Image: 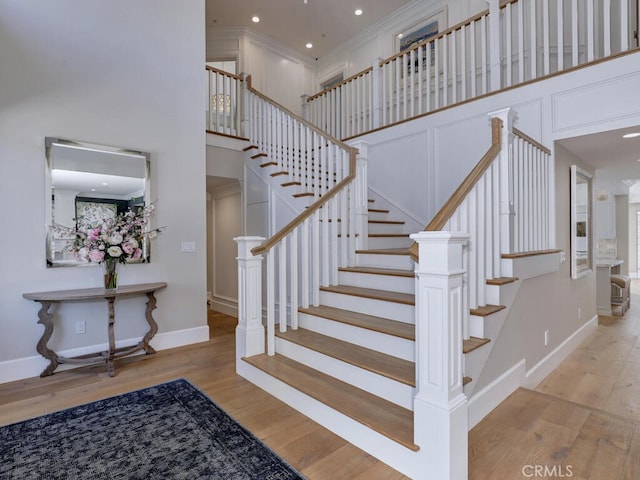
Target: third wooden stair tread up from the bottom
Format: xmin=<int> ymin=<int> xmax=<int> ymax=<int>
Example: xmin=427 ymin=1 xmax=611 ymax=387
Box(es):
xmin=298 ymin=305 xmax=416 ymax=341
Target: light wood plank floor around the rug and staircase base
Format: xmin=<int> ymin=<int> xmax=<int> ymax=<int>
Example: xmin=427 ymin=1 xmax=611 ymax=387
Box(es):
xmin=0 ymin=281 xmax=640 ymax=480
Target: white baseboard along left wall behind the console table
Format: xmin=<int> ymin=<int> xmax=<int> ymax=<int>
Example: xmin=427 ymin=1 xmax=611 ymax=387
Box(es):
xmin=0 ymin=326 xmax=209 ymax=383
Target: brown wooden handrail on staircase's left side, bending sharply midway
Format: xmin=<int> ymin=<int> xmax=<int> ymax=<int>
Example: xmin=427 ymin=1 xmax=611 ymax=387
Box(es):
xmin=247 ymin=76 xmax=358 ymax=255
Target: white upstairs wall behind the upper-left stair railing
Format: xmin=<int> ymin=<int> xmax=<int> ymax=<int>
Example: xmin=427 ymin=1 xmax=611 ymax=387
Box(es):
xmin=207 ymin=28 xmax=315 ymax=115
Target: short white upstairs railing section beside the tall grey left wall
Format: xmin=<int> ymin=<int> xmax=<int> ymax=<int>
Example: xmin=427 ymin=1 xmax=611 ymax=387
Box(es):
xmin=205 ymin=65 xmax=242 ymax=137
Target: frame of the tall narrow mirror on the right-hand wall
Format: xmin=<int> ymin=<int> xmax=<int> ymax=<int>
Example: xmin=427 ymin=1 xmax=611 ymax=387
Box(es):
xmin=569 ymin=165 xmax=593 ymax=279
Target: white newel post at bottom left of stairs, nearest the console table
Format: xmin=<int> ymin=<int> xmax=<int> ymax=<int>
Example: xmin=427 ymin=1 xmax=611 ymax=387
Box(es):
xmin=234 ymin=237 xmax=265 ymax=363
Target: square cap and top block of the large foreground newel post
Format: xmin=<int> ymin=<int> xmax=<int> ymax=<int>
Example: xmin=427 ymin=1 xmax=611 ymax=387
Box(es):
xmin=410 ymin=232 xmax=469 ymax=274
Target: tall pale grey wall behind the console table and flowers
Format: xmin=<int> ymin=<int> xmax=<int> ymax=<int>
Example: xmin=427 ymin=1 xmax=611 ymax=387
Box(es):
xmin=0 ymin=0 xmax=208 ymax=382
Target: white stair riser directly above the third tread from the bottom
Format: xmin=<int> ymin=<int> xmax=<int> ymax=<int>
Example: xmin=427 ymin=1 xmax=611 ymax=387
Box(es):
xmin=320 ymin=291 xmax=415 ymax=324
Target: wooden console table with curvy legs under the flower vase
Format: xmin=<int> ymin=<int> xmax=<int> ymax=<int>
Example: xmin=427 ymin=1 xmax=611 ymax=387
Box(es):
xmin=22 ymin=282 xmax=167 ymax=377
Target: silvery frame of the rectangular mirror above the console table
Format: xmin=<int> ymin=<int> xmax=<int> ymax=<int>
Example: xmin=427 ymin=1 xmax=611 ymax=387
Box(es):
xmin=45 ymin=137 xmax=152 ymax=268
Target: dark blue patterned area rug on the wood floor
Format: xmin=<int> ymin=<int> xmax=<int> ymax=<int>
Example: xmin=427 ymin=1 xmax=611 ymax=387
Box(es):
xmin=0 ymin=380 xmax=304 ymax=480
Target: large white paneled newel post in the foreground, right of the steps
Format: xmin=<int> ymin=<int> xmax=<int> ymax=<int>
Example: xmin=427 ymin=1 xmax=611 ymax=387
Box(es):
xmin=411 ymin=232 xmax=469 ymax=480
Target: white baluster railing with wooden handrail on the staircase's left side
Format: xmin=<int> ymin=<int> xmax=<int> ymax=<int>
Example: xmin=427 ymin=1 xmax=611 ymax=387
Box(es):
xmin=239 ymin=77 xmax=359 ymax=355
